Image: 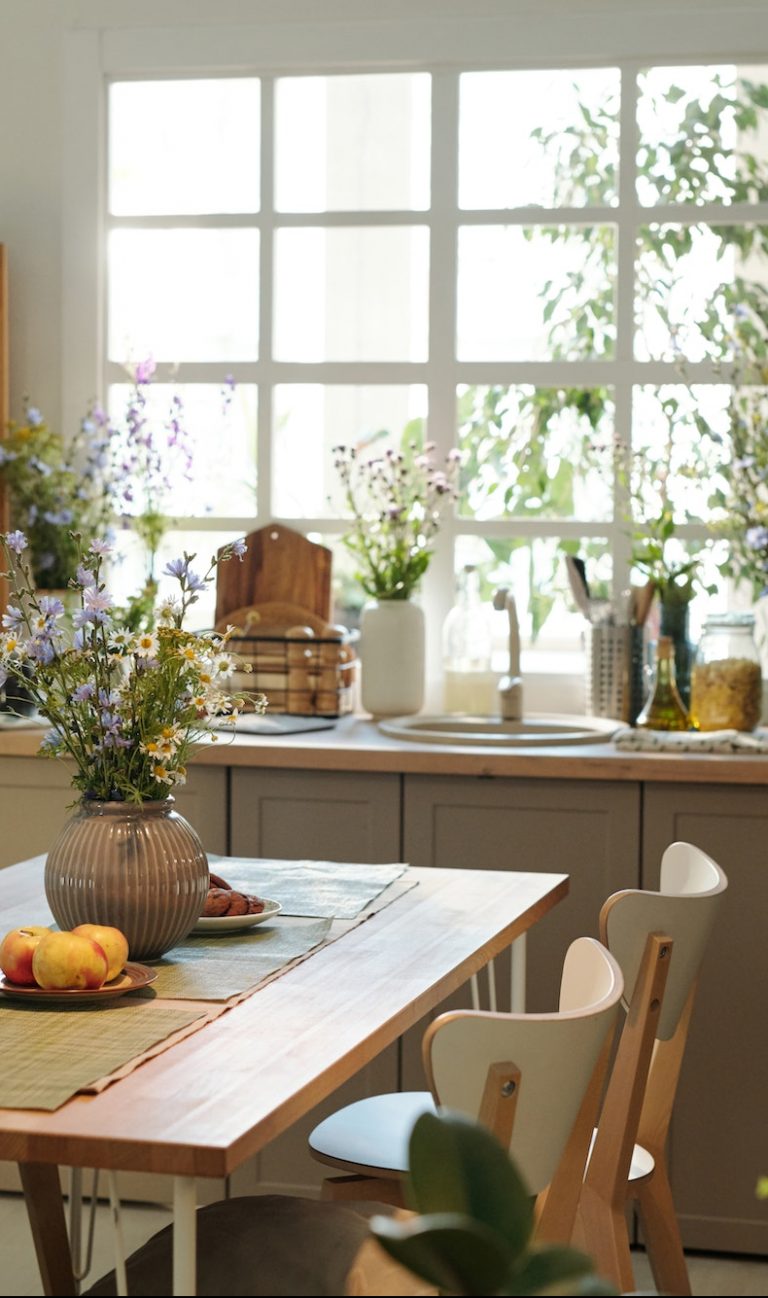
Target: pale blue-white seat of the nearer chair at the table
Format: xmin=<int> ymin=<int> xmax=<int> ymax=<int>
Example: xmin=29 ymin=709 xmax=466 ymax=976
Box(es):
xmin=309 ymin=1090 xmax=435 ymax=1177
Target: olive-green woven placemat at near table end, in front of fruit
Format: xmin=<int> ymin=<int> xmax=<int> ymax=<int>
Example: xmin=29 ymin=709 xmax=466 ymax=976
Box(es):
xmin=0 ymin=999 xmax=201 ymax=1110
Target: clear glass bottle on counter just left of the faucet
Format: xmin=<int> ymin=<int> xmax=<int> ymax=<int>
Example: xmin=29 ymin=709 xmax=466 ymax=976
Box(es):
xmin=442 ymin=563 xmax=498 ymax=716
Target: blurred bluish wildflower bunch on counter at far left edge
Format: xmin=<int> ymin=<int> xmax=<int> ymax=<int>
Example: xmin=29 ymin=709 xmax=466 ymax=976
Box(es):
xmin=0 ymin=404 xmax=113 ymax=589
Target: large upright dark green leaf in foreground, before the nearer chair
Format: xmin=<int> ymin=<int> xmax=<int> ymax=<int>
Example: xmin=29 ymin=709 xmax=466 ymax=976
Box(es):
xmin=409 ymin=1112 xmax=533 ymax=1263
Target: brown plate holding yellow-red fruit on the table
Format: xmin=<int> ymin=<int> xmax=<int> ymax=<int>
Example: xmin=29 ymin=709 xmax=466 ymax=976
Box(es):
xmin=0 ymin=924 xmax=157 ymax=1001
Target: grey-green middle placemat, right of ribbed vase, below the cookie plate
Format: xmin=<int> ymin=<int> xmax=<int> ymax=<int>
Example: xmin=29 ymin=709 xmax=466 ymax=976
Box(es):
xmin=147 ymin=919 xmax=331 ymax=1001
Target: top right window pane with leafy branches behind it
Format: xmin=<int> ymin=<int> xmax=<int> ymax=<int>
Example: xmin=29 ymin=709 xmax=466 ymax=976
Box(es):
xmin=637 ymin=66 xmax=768 ymax=206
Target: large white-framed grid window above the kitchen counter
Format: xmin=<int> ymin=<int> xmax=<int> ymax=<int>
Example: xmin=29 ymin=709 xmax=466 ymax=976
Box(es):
xmin=97 ymin=49 xmax=768 ymax=695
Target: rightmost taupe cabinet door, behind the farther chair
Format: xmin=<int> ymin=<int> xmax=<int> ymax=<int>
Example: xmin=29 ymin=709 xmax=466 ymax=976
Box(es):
xmin=642 ymin=778 xmax=768 ymax=1254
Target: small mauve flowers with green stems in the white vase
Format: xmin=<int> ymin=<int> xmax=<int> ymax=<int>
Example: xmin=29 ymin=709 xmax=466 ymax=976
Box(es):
xmin=333 ymin=443 xmax=461 ymax=600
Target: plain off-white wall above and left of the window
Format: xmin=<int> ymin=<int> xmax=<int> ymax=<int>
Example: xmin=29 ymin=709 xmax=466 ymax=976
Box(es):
xmin=0 ymin=0 xmax=768 ymax=423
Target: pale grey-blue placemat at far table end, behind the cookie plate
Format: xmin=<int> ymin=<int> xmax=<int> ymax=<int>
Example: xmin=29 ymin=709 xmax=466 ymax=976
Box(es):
xmin=209 ymin=857 xmax=407 ymax=919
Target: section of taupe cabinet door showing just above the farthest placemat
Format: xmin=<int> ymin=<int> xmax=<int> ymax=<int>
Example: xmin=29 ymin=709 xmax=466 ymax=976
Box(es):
xmin=230 ymin=770 xmax=401 ymax=864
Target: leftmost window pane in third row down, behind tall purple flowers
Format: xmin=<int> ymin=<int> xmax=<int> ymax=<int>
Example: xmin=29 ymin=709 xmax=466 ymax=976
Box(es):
xmin=109 ymin=382 xmax=256 ymax=518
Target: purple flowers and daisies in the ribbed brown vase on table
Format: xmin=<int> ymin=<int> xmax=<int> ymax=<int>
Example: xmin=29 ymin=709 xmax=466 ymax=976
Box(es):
xmin=0 ymin=531 xmax=265 ymax=802
